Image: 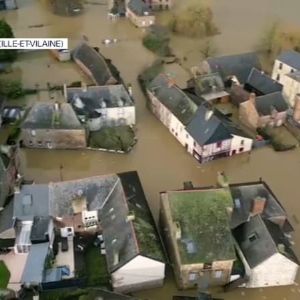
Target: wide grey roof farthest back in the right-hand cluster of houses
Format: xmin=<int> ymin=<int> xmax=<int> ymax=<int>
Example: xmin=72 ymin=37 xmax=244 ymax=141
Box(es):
xmin=207 ymin=52 xmax=260 ymax=83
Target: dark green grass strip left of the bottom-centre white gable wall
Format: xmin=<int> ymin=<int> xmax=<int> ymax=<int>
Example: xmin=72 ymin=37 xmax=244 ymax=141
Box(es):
xmin=84 ymin=246 xmax=110 ymax=286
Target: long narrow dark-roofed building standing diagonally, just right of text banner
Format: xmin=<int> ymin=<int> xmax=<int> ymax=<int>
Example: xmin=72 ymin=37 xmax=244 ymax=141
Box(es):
xmin=72 ymin=42 xmax=119 ymax=85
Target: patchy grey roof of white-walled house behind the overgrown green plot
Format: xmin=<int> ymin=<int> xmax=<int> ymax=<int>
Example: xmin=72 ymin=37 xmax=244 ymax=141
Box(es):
xmin=67 ymin=84 xmax=134 ymax=114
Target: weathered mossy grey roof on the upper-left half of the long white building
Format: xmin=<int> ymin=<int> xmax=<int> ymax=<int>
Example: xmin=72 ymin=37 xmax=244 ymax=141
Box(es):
xmin=147 ymin=74 xmax=197 ymax=125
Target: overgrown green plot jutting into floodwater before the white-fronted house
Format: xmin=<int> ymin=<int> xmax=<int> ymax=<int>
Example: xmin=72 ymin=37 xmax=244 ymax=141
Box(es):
xmin=89 ymin=126 xmax=135 ymax=152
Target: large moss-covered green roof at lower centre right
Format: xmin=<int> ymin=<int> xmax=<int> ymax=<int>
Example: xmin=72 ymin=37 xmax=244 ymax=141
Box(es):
xmin=161 ymin=189 xmax=235 ymax=264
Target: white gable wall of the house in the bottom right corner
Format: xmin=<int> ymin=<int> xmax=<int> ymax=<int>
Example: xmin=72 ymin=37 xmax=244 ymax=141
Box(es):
xmin=246 ymin=253 xmax=298 ymax=288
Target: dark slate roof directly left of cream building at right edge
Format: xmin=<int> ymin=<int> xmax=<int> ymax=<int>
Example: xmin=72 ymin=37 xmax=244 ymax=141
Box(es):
xmin=245 ymin=68 xmax=283 ymax=95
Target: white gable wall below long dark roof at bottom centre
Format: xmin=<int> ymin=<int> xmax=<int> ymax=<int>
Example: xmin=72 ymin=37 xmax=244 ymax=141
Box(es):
xmin=112 ymin=255 xmax=165 ymax=291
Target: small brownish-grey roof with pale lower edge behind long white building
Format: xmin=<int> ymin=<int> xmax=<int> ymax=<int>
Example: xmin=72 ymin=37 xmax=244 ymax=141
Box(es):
xmin=194 ymin=73 xmax=228 ymax=101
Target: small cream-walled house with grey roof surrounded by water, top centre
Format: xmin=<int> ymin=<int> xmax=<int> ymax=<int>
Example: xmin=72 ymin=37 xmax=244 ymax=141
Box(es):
xmin=126 ymin=0 xmax=155 ymax=28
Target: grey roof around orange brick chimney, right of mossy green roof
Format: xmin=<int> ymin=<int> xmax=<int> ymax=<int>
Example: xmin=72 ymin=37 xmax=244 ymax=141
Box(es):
xmin=230 ymin=182 xmax=287 ymax=228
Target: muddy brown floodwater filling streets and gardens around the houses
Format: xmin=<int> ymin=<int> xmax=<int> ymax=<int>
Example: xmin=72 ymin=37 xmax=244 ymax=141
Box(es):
xmin=0 ymin=0 xmax=300 ymax=300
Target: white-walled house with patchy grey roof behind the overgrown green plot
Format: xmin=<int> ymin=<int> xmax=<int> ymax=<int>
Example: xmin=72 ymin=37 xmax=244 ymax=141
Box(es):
xmin=65 ymin=84 xmax=135 ymax=131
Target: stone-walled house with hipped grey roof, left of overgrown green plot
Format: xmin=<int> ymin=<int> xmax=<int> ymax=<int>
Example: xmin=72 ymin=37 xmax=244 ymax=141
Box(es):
xmin=21 ymin=102 xmax=86 ymax=149
